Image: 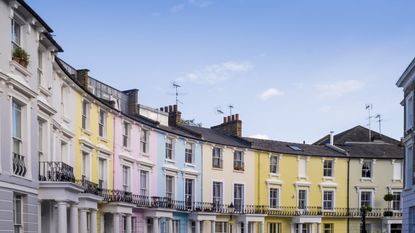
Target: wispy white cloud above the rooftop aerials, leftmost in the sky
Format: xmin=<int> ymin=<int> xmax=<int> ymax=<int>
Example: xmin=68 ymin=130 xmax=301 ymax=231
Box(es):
xmin=178 ymin=61 xmax=253 ymax=85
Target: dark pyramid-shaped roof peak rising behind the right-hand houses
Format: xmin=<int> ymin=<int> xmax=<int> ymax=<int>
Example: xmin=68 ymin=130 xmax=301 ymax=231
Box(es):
xmin=314 ymin=125 xmax=400 ymax=145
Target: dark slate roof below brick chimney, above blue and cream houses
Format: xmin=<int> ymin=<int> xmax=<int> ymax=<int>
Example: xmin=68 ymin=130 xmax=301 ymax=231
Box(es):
xmin=180 ymin=125 xmax=250 ymax=148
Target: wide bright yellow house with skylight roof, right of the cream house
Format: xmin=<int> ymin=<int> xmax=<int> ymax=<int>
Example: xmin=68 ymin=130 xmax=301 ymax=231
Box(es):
xmin=248 ymin=139 xmax=348 ymax=233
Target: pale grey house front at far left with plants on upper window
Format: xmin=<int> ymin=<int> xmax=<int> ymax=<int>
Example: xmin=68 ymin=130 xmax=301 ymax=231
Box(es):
xmin=0 ymin=0 xmax=61 ymax=232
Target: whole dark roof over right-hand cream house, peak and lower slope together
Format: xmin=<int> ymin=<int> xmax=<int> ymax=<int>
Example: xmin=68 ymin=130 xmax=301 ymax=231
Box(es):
xmin=314 ymin=125 xmax=404 ymax=159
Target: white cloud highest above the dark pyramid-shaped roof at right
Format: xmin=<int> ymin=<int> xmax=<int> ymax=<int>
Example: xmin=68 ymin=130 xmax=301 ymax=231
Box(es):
xmin=315 ymin=80 xmax=364 ymax=97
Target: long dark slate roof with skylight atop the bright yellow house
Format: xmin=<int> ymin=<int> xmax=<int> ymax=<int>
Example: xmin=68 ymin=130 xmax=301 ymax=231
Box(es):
xmin=244 ymin=138 xmax=346 ymax=157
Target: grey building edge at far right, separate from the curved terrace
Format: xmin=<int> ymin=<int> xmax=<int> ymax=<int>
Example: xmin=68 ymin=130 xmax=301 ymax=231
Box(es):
xmin=396 ymin=59 xmax=415 ymax=233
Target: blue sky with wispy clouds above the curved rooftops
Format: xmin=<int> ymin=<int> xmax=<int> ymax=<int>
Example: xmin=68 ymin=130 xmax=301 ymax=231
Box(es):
xmin=27 ymin=0 xmax=415 ymax=143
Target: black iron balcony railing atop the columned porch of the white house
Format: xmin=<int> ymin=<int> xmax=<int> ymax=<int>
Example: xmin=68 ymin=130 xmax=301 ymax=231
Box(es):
xmin=39 ymin=161 xmax=75 ymax=183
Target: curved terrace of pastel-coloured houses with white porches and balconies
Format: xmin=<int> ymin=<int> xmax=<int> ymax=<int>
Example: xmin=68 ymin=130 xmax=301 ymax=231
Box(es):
xmin=0 ymin=0 xmax=404 ymax=233
